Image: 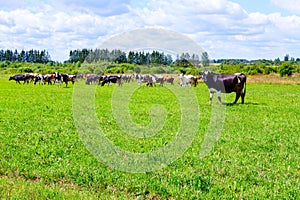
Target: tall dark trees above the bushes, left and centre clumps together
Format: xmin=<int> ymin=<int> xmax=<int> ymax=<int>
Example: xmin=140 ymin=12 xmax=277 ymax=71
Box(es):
xmin=0 ymin=48 xmax=209 ymax=67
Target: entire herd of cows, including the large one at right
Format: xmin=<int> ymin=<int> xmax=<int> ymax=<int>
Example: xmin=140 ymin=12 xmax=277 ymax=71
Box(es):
xmin=9 ymin=71 xmax=246 ymax=104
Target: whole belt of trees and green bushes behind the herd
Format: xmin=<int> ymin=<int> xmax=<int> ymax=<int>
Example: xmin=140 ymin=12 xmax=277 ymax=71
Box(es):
xmin=0 ymin=49 xmax=300 ymax=76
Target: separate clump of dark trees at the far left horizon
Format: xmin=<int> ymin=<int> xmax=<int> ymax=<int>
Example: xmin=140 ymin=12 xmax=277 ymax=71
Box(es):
xmin=0 ymin=49 xmax=51 ymax=63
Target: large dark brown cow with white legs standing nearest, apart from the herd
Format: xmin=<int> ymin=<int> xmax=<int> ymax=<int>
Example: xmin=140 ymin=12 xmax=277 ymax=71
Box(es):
xmin=203 ymin=71 xmax=247 ymax=104
